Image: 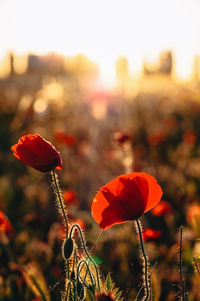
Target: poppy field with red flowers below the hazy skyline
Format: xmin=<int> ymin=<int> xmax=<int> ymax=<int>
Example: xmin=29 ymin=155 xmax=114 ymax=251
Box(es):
xmin=0 ymin=73 xmax=200 ymax=301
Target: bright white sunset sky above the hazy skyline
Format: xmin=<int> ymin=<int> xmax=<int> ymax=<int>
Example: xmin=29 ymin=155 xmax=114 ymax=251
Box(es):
xmin=0 ymin=0 xmax=200 ymax=78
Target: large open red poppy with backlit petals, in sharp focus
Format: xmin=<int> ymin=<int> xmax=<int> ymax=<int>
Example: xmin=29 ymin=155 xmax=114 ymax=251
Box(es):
xmin=91 ymin=172 xmax=162 ymax=229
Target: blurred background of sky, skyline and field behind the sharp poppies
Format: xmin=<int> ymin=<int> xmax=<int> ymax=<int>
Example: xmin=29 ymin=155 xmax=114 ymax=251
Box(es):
xmin=0 ymin=0 xmax=200 ymax=301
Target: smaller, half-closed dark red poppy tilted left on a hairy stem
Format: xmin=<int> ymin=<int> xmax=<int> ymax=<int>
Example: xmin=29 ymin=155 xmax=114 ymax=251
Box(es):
xmin=11 ymin=134 xmax=62 ymax=172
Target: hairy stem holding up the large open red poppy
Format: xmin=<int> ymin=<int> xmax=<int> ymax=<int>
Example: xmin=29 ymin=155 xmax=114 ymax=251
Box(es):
xmin=136 ymin=219 xmax=149 ymax=301
